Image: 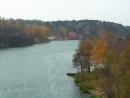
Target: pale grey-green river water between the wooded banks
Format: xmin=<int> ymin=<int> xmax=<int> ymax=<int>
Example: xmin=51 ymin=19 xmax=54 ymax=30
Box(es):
xmin=0 ymin=41 xmax=86 ymax=98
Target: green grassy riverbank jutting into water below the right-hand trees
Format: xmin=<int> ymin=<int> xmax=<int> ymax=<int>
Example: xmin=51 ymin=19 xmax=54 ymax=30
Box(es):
xmin=67 ymin=72 xmax=102 ymax=98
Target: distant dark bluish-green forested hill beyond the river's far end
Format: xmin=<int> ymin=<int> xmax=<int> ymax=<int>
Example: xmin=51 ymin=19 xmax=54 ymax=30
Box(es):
xmin=25 ymin=20 xmax=130 ymax=39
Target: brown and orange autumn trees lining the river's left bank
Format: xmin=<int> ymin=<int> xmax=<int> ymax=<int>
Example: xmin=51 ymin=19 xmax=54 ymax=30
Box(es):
xmin=0 ymin=18 xmax=49 ymax=48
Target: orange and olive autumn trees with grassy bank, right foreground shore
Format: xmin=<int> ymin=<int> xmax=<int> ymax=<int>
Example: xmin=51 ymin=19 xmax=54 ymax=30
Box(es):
xmin=73 ymin=33 xmax=130 ymax=98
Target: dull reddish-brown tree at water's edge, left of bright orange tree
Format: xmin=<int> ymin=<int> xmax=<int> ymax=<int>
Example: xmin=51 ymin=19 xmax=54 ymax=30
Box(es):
xmin=73 ymin=38 xmax=92 ymax=72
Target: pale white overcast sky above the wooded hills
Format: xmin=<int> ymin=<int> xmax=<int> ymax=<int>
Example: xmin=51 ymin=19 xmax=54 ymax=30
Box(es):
xmin=0 ymin=0 xmax=130 ymax=25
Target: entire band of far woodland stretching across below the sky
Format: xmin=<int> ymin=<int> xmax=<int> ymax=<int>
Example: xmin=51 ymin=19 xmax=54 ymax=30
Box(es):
xmin=0 ymin=18 xmax=130 ymax=48
